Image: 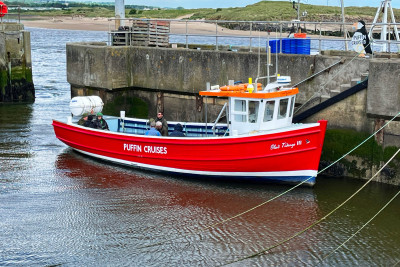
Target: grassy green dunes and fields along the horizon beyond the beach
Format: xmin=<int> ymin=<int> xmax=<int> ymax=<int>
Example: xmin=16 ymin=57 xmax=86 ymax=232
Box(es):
xmin=8 ymin=1 xmax=400 ymax=22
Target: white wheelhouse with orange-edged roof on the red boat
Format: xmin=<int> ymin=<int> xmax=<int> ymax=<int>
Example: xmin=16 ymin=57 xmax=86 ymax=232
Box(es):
xmin=200 ymin=77 xmax=298 ymax=136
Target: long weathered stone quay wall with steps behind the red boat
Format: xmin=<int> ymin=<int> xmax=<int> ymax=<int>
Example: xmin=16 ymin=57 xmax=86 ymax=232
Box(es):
xmin=67 ymin=43 xmax=400 ymax=184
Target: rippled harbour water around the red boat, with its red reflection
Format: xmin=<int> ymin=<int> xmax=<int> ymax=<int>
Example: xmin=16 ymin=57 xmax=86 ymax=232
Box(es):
xmin=0 ymin=29 xmax=400 ymax=266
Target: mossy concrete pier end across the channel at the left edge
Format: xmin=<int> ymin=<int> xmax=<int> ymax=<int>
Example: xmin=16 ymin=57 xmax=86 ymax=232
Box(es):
xmin=0 ymin=23 xmax=35 ymax=102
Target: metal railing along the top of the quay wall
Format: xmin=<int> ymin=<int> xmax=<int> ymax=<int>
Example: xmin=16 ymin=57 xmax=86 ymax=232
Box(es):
xmin=109 ymin=18 xmax=400 ymax=52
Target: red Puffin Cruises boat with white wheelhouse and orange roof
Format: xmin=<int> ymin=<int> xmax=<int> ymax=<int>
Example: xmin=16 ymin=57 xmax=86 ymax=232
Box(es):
xmin=53 ymin=77 xmax=327 ymax=185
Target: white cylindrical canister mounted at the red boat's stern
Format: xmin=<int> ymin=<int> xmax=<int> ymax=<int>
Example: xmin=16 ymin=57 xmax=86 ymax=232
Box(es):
xmin=69 ymin=95 xmax=104 ymax=116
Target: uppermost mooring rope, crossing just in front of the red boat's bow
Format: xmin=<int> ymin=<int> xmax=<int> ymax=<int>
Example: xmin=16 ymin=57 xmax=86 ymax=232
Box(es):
xmin=138 ymin=112 xmax=400 ymax=251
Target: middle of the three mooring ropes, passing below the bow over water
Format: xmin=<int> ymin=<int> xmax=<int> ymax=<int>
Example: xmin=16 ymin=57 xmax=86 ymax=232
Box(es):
xmin=222 ymin=149 xmax=400 ymax=266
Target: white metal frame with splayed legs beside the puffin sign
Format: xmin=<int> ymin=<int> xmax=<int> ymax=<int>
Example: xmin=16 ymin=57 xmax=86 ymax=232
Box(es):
xmin=368 ymin=0 xmax=400 ymax=52
